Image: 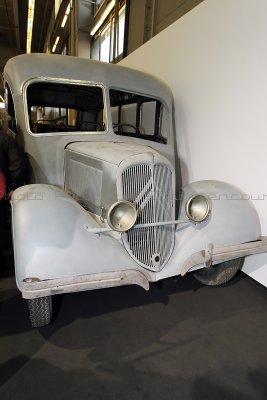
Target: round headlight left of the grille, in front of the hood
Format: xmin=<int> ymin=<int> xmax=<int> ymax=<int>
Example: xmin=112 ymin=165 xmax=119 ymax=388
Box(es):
xmin=107 ymin=200 xmax=137 ymax=232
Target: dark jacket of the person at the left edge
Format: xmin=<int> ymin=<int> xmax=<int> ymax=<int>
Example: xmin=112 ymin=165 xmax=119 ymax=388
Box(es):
xmin=0 ymin=131 xmax=25 ymax=193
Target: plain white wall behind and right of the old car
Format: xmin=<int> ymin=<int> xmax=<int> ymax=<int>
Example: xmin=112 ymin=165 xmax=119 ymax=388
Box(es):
xmin=121 ymin=0 xmax=267 ymax=286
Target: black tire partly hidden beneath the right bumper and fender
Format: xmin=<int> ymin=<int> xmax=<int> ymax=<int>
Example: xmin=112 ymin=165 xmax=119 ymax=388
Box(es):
xmin=193 ymin=258 xmax=244 ymax=286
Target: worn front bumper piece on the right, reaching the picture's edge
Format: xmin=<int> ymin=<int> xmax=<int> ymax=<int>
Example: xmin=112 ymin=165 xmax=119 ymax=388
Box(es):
xmin=181 ymin=236 xmax=267 ymax=276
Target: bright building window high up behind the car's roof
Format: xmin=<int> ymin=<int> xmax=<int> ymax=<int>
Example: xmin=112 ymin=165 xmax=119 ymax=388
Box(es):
xmin=91 ymin=1 xmax=126 ymax=62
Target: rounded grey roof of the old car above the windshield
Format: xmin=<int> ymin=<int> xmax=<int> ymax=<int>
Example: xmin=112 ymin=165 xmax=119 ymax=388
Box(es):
xmin=3 ymin=53 xmax=171 ymax=102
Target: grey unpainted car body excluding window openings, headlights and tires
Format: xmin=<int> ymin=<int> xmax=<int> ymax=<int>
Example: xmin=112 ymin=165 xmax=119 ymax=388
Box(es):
xmin=4 ymin=54 xmax=267 ymax=324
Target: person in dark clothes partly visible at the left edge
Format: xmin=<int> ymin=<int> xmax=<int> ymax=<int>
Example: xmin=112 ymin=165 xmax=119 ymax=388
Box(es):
xmin=0 ymin=109 xmax=25 ymax=253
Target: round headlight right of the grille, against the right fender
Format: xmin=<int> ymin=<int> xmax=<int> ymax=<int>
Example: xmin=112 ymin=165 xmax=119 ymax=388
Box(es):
xmin=185 ymin=194 xmax=211 ymax=223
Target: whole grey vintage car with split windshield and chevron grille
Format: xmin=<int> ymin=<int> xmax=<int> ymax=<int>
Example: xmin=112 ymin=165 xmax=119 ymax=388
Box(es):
xmin=3 ymin=54 xmax=267 ymax=327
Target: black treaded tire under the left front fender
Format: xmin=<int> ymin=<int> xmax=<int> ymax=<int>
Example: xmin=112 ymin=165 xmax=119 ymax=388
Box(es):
xmin=26 ymin=296 xmax=52 ymax=328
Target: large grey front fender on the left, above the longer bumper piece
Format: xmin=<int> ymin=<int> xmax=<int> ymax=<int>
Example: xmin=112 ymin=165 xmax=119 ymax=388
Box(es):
xmin=12 ymin=184 xmax=139 ymax=289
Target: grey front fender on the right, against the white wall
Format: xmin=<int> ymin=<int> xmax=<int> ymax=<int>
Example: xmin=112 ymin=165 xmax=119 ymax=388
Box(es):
xmin=158 ymin=181 xmax=261 ymax=279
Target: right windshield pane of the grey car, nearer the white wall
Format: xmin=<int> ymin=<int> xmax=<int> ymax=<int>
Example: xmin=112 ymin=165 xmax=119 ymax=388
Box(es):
xmin=110 ymin=89 xmax=168 ymax=143
